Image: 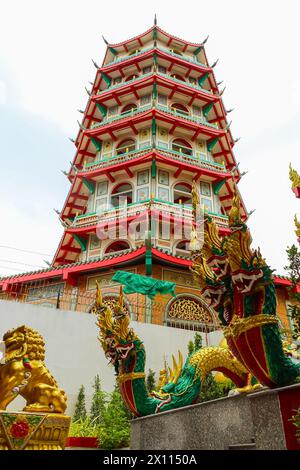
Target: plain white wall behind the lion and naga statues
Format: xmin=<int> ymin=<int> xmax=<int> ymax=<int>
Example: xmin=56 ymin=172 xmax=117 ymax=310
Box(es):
xmin=0 ymin=300 xmax=222 ymax=414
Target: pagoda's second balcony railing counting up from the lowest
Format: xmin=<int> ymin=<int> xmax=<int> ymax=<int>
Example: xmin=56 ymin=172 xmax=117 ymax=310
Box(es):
xmin=78 ymin=145 xmax=227 ymax=176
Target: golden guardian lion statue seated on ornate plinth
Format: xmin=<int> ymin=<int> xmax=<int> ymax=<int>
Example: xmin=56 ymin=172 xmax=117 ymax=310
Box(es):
xmin=0 ymin=325 xmax=67 ymax=413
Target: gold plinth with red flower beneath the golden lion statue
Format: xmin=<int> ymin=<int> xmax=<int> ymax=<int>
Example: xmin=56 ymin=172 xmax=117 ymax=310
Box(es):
xmin=0 ymin=411 xmax=71 ymax=450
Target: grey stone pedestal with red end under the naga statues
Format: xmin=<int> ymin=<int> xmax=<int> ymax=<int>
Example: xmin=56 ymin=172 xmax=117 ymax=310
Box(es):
xmin=131 ymin=384 xmax=300 ymax=450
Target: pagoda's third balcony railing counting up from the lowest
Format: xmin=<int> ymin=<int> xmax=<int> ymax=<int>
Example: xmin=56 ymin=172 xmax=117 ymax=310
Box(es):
xmin=90 ymin=100 xmax=218 ymax=129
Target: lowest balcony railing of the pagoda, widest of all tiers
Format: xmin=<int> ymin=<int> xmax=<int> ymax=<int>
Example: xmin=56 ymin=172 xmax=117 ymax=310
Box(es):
xmin=67 ymin=198 xmax=228 ymax=233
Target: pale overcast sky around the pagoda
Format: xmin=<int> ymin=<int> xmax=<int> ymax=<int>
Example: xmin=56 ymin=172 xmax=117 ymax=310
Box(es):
xmin=0 ymin=0 xmax=300 ymax=275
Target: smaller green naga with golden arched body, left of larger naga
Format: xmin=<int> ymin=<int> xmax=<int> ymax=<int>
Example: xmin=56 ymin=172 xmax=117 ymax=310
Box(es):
xmin=92 ymin=286 xmax=253 ymax=416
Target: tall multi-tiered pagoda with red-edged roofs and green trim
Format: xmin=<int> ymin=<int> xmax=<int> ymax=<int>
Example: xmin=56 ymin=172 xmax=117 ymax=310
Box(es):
xmin=0 ymin=24 xmax=289 ymax=329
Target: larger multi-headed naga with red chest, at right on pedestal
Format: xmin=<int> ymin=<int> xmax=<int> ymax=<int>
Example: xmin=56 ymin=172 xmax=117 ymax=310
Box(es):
xmin=191 ymin=189 xmax=300 ymax=388
